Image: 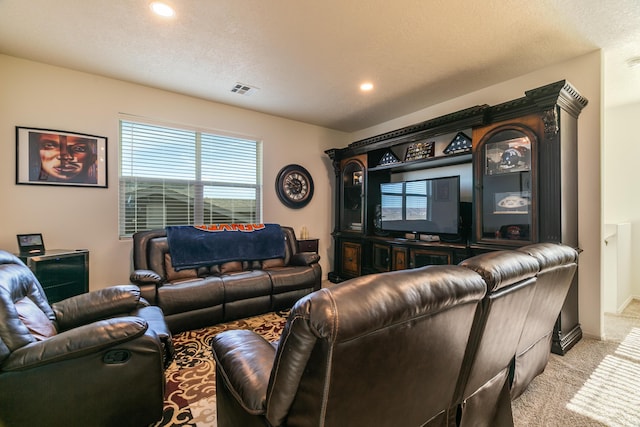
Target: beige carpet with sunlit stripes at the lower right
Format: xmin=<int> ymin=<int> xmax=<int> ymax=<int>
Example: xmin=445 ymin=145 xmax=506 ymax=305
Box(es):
xmin=513 ymin=301 xmax=640 ymax=427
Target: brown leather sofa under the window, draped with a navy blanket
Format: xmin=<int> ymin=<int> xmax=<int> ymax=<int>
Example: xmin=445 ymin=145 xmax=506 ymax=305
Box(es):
xmin=130 ymin=226 xmax=322 ymax=333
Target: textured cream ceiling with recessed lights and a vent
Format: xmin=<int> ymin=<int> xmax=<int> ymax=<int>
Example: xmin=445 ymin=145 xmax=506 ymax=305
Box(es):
xmin=0 ymin=0 xmax=640 ymax=132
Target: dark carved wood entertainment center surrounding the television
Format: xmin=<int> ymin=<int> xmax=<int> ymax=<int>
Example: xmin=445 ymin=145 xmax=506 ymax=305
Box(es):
xmin=326 ymin=80 xmax=588 ymax=354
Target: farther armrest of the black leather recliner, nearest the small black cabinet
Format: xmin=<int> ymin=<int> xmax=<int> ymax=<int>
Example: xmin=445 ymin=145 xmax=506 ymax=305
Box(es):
xmin=51 ymin=285 xmax=140 ymax=331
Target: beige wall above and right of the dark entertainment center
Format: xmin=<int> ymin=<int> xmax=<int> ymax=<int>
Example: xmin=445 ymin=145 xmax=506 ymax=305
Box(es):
xmin=352 ymin=51 xmax=604 ymax=337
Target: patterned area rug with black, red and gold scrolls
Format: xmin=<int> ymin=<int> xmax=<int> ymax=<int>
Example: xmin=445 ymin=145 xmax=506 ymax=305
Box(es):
xmin=153 ymin=312 xmax=287 ymax=427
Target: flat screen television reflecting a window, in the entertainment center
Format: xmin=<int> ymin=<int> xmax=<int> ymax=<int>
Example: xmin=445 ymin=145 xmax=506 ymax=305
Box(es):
xmin=380 ymin=176 xmax=460 ymax=236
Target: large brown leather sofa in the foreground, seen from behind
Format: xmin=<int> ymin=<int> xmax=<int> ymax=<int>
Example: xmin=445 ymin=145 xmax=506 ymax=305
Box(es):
xmin=212 ymin=244 xmax=577 ymax=427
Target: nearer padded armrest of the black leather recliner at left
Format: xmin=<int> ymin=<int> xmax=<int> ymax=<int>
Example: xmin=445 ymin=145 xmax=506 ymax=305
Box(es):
xmin=2 ymin=317 xmax=148 ymax=372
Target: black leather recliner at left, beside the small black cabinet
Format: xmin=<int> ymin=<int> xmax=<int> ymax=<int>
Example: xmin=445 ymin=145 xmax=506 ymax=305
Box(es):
xmin=0 ymin=251 xmax=173 ymax=427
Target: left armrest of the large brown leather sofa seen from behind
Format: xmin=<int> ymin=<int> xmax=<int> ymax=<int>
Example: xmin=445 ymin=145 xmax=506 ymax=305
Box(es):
xmin=212 ymin=330 xmax=276 ymax=415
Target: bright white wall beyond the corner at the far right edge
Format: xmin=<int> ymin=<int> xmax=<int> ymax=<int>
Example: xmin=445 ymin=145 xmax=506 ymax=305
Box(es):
xmin=603 ymin=104 xmax=640 ymax=306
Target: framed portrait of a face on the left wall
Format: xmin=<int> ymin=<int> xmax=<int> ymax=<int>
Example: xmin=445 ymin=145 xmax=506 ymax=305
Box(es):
xmin=16 ymin=126 xmax=107 ymax=188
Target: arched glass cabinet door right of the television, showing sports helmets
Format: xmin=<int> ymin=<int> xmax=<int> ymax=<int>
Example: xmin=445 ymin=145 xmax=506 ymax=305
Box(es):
xmin=474 ymin=120 xmax=538 ymax=246
